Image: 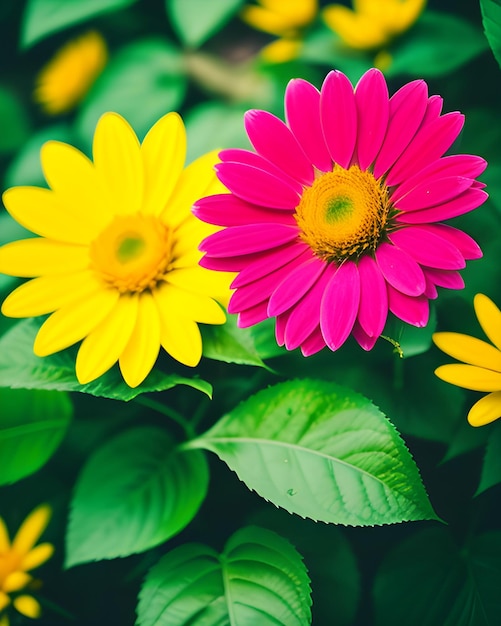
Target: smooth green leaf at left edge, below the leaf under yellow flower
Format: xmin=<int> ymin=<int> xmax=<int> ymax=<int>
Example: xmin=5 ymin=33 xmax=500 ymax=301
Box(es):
xmin=0 ymin=389 xmax=73 ymax=485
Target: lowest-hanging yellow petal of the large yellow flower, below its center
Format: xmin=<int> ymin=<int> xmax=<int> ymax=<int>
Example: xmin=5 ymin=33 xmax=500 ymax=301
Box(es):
xmin=119 ymin=291 xmax=160 ymax=387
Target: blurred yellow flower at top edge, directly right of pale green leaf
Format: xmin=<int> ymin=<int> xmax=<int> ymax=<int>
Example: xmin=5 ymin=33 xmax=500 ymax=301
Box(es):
xmin=241 ymin=0 xmax=318 ymax=63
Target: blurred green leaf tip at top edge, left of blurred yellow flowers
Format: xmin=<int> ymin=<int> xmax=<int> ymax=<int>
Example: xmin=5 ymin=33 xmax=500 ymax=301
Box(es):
xmin=165 ymin=0 xmax=244 ymax=47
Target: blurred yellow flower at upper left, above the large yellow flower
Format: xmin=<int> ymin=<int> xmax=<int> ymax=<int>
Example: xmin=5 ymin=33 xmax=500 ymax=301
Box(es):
xmin=33 ymin=31 xmax=108 ymax=115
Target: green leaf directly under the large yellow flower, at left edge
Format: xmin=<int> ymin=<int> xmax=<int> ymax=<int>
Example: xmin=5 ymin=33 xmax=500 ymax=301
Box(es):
xmin=0 ymin=319 xmax=212 ymax=401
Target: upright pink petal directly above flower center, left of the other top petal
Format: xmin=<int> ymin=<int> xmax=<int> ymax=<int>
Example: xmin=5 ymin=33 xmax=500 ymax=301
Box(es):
xmin=320 ymin=71 xmax=357 ymax=169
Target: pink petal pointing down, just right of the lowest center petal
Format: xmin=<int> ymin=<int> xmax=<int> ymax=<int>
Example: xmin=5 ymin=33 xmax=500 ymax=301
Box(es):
xmin=358 ymin=256 xmax=388 ymax=336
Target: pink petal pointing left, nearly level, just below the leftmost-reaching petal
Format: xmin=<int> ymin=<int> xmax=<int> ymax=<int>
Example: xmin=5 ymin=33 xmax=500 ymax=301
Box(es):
xmin=199 ymin=224 xmax=299 ymax=257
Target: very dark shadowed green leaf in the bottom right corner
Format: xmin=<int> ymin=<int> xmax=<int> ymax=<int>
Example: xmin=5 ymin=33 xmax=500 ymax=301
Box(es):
xmin=374 ymin=528 xmax=501 ymax=626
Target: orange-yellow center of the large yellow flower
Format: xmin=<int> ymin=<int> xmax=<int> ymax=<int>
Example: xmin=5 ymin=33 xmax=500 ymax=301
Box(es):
xmin=90 ymin=215 xmax=172 ymax=293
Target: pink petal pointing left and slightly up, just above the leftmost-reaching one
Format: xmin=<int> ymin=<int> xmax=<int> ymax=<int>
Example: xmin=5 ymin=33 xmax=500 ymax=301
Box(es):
xmin=215 ymin=162 xmax=300 ymax=211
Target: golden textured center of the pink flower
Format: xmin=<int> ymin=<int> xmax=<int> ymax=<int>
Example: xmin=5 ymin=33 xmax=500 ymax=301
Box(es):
xmin=294 ymin=164 xmax=391 ymax=263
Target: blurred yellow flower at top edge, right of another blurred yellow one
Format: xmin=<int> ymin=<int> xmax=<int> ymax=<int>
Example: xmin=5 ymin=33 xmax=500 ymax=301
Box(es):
xmin=322 ymin=0 xmax=426 ymax=50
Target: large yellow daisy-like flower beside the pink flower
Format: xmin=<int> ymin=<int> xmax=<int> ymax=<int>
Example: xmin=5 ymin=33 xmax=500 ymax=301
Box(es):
xmin=0 ymin=113 xmax=232 ymax=387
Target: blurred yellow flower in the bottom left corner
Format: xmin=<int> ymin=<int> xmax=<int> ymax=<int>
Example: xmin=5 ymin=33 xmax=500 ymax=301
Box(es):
xmin=0 ymin=504 xmax=54 ymax=626
